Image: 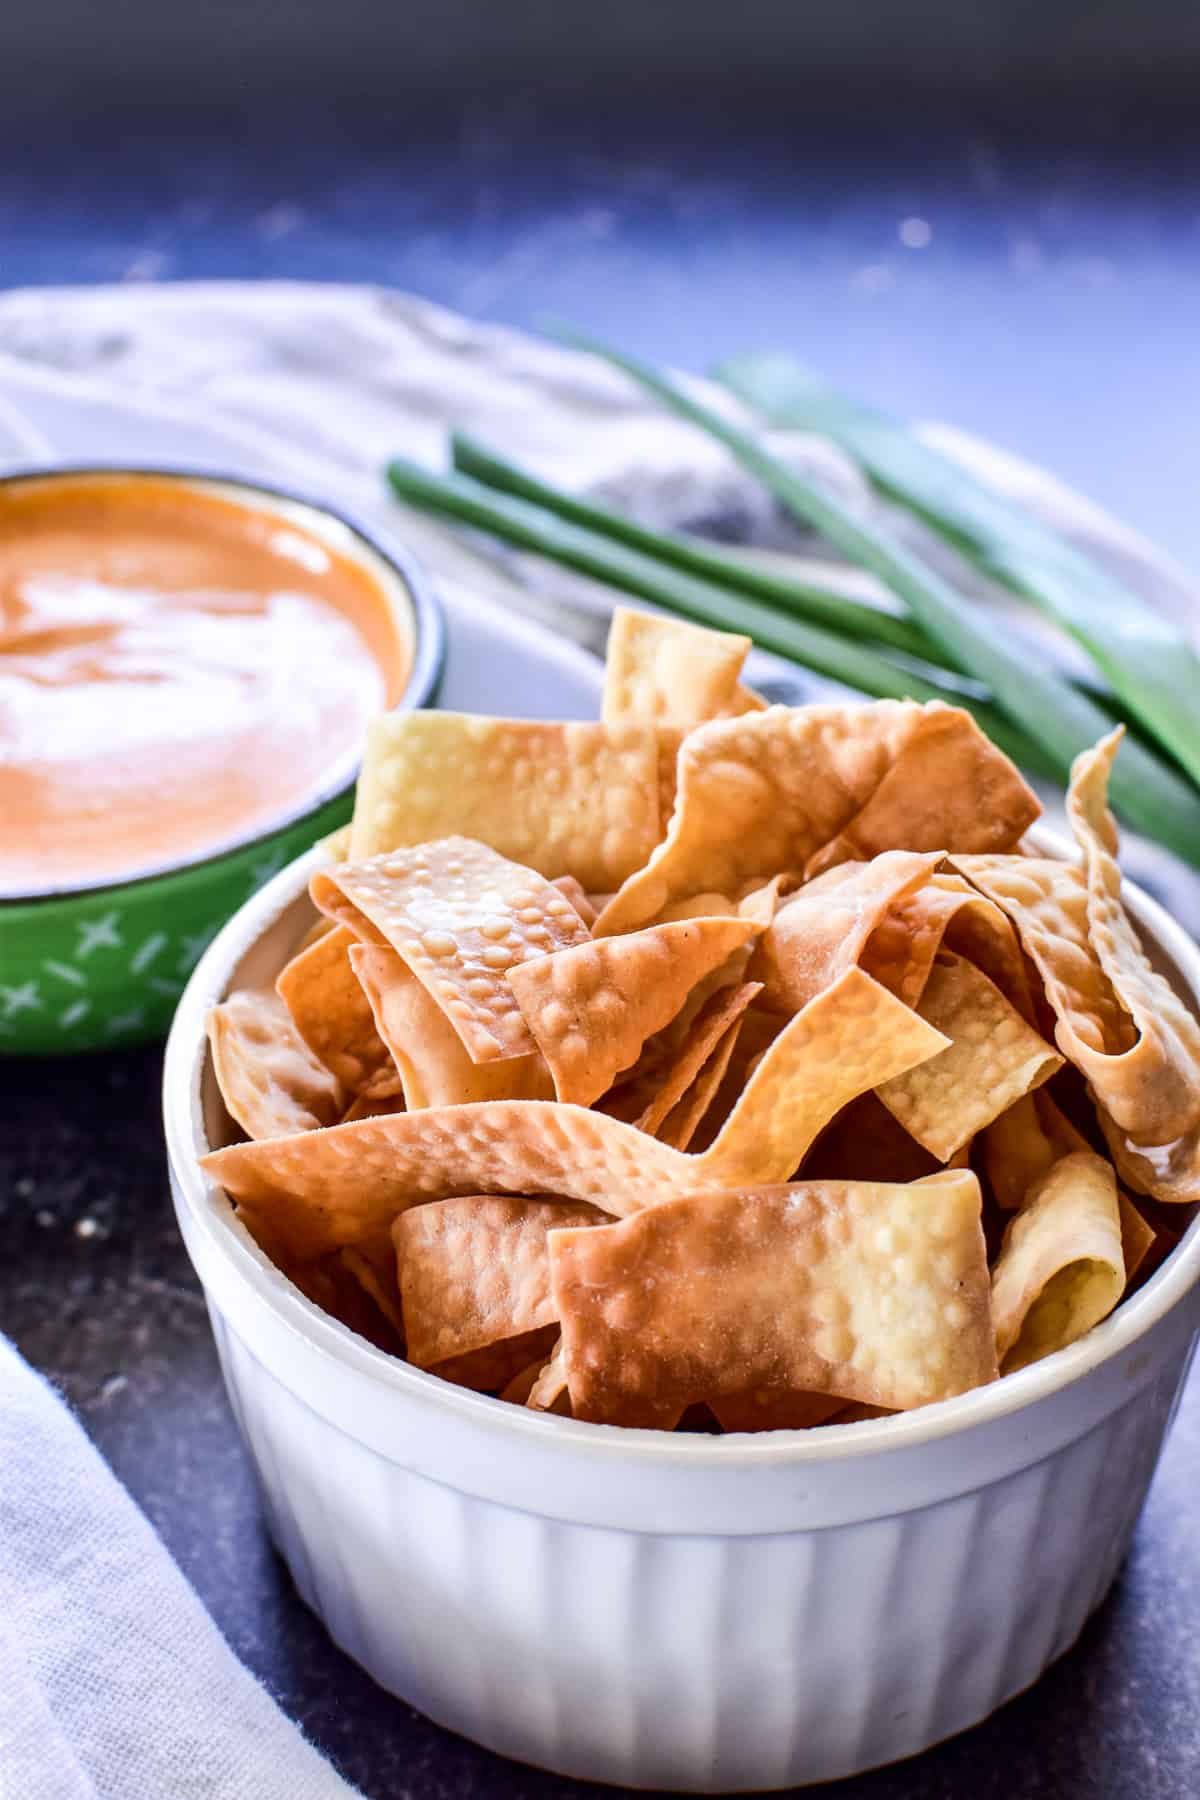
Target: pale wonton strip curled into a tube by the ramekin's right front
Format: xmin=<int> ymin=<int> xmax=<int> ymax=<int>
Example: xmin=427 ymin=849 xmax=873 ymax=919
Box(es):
xmin=991 ymin=1150 xmax=1124 ymax=1372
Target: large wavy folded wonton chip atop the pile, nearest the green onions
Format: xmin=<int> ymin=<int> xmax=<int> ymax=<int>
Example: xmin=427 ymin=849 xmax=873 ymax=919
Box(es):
xmin=596 ymin=700 xmax=1040 ymax=934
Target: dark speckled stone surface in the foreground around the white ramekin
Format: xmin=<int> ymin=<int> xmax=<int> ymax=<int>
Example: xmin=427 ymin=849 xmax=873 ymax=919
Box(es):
xmin=0 ymin=1051 xmax=1200 ymax=1800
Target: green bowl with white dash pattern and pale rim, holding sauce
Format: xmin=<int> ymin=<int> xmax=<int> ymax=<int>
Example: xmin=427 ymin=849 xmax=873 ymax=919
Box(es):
xmin=0 ymin=464 xmax=444 ymax=1055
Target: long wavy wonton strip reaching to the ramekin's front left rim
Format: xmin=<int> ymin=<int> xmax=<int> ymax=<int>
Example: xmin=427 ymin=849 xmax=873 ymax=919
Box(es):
xmin=201 ymin=1100 xmax=698 ymax=1262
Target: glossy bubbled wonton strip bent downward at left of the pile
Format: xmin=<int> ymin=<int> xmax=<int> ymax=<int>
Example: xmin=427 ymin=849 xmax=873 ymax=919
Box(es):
xmin=311 ymin=837 xmax=590 ymax=1062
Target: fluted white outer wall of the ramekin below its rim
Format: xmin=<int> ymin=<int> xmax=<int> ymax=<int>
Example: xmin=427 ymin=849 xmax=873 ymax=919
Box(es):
xmin=212 ymin=1309 xmax=1195 ymax=1793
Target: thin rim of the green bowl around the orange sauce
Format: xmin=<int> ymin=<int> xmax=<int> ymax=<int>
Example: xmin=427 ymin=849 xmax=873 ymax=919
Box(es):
xmin=0 ymin=461 xmax=446 ymax=909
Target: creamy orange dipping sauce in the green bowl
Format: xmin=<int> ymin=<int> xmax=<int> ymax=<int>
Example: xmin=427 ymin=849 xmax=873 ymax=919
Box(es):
xmin=0 ymin=473 xmax=412 ymax=896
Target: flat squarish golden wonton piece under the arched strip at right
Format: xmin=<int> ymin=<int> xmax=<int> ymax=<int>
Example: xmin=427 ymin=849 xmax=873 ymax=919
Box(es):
xmin=876 ymin=952 xmax=1063 ymax=1163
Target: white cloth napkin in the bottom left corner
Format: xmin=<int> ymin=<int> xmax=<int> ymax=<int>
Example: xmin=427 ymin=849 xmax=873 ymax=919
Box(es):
xmin=0 ymin=1339 xmax=356 ymax=1800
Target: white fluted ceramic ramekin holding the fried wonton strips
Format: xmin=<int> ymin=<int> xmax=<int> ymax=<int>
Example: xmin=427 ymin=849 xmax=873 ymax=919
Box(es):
xmin=166 ymin=839 xmax=1200 ymax=1793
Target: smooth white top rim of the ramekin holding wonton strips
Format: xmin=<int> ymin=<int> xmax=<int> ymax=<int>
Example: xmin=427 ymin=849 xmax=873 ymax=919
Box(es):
xmin=164 ymin=824 xmax=1200 ymax=1472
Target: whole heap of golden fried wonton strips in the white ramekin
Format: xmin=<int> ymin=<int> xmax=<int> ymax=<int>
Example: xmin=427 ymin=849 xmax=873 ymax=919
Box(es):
xmin=205 ymin=612 xmax=1200 ymax=1431
